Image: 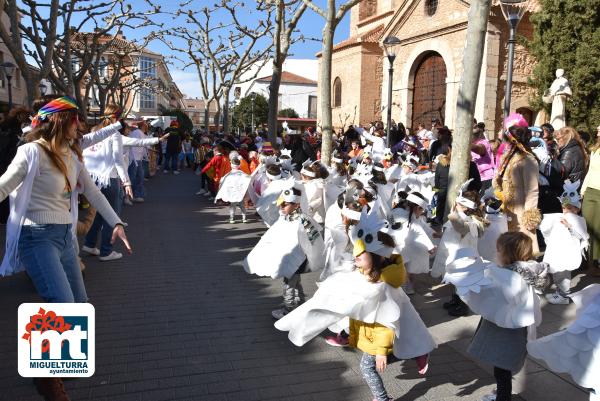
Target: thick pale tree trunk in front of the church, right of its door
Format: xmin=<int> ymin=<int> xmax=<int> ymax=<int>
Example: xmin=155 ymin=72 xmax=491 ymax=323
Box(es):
xmin=446 ymin=0 xmax=491 ymax=216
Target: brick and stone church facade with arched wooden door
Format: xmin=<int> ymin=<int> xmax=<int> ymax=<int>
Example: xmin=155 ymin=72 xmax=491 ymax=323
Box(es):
xmin=319 ymin=0 xmax=537 ymax=131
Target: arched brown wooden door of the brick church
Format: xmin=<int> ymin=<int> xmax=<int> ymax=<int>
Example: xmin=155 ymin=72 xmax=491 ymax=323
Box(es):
xmin=411 ymin=52 xmax=446 ymax=130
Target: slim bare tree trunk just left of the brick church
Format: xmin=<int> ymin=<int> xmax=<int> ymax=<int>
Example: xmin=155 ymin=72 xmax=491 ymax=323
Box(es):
xmin=320 ymin=19 xmax=335 ymax=166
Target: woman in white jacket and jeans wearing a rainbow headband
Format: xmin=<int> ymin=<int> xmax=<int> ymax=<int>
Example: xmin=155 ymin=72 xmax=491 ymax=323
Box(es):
xmin=0 ymin=97 xmax=131 ymax=399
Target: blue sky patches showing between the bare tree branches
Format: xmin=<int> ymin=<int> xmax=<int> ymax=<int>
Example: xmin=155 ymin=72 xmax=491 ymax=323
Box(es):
xmin=17 ymin=0 xmax=350 ymax=97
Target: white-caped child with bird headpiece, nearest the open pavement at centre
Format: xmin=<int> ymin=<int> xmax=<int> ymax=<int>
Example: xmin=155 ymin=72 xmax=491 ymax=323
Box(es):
xmin=243 ymin=181 xmax=325 ymax=319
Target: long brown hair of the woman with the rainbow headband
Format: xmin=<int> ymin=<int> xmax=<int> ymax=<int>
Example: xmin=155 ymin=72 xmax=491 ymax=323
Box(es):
xmin=25 ymin=109 xmax=83 ymax=191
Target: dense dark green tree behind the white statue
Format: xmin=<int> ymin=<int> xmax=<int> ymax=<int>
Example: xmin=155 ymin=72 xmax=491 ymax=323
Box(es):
xmin=527 ymin=0 xmax=600 ymax=132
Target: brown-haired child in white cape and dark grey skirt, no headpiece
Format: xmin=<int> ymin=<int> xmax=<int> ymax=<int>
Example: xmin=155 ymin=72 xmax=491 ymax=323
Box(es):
xmin=444 ymin=231 xmax=549 ymax=401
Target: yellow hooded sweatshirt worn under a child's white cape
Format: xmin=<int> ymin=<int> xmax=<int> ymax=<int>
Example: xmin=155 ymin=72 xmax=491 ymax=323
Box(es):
xmin=348 ymin=255 xmax=406 ymax=355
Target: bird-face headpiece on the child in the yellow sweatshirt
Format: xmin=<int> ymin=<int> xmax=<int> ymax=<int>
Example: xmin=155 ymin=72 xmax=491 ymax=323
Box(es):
xmin=350 ymin=207 xmax=394 ymax=258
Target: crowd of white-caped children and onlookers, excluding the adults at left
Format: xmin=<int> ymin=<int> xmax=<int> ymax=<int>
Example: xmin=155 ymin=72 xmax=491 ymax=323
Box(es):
xmin=196 ymin=114 xmax=600 ymax=401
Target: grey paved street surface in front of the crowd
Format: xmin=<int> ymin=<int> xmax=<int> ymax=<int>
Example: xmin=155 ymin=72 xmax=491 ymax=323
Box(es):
xmin=0 ymin=172 xmax=587 ymax=401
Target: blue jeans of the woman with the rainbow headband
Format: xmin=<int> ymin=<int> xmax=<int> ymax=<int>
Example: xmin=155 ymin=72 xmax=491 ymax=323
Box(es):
xmin=19 ymin=224 xmax=88 ymax=302
